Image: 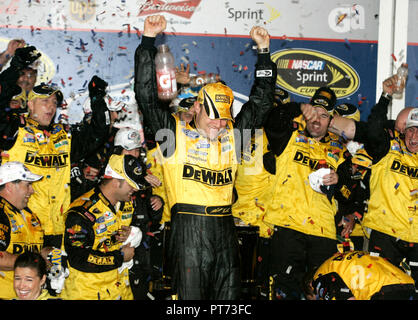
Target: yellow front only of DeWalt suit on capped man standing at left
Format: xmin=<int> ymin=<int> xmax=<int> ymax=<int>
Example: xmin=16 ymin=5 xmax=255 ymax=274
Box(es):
xmin=2 ymin=118 xmax=71 ymax=241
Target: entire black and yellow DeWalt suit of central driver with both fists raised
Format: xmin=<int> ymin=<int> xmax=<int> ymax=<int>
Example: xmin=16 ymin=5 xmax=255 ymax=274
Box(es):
xmin=135 ymin=36 xmax=276 ymax=299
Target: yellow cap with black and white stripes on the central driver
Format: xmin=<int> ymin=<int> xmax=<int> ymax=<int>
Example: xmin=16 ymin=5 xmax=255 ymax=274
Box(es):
xmin=197 ymin=82 xmax=234 ymax=121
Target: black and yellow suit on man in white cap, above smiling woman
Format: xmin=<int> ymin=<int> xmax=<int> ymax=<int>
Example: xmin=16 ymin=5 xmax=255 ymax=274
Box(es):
xmin=0 ymin=198 xmax=44 ymax=300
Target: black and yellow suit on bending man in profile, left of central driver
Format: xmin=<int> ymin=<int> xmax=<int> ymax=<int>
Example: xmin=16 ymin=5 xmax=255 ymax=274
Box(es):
xmin=60 ymin=187 xmax=134 ymax=300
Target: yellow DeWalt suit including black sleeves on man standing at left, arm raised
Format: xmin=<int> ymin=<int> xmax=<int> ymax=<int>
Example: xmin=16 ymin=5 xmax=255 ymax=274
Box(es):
xmin=0 ymin=85 xmax=110 ymax=248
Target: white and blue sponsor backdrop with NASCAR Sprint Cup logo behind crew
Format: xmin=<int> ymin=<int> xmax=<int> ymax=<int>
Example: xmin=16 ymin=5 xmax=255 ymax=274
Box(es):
xmin=0 ymin=0 xmax=418 ymax=123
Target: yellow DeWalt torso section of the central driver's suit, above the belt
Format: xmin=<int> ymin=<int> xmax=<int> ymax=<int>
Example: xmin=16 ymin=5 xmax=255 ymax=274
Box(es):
xmin=155 ymin=115 xmax=236 ymax=216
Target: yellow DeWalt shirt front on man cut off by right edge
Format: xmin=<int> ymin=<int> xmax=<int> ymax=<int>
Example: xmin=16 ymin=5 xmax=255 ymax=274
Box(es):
xmin=363 ymin=131 xmax=418 ymax=243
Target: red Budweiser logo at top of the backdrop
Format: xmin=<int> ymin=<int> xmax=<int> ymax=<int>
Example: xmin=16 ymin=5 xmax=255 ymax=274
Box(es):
xmin=138 ymin=0 xmax=201 ymax=19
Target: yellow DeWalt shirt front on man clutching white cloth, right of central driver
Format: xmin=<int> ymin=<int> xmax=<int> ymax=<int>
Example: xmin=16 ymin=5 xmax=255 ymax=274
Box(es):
xmin=264 ymin=124 xmax=346 ymax=239
